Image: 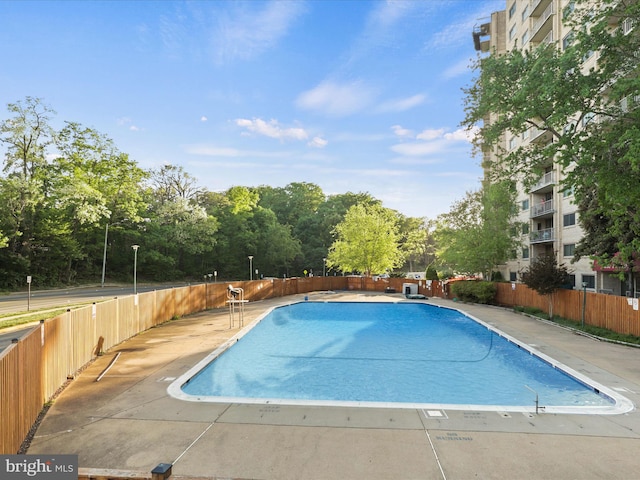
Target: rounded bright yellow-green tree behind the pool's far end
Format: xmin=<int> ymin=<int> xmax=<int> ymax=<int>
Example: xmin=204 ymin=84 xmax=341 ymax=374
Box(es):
xmin=327 ymin=204 xmax=403 ymax=275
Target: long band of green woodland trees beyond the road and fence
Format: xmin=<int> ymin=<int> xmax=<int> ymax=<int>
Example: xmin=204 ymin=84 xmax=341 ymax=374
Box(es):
xmin=0 ymin=97 xmax=436 ymax=289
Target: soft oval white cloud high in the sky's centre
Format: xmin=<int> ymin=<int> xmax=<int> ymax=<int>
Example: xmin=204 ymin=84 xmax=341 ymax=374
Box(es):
xmin=297 ymin=82 xmax=375 ymax=116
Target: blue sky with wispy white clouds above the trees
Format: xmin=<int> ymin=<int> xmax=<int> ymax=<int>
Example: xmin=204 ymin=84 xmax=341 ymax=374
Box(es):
xmin=0 ymin=0 xmax=505 ymax=218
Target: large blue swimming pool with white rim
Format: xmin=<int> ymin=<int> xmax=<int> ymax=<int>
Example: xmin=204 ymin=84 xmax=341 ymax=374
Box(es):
xmin=169 ymin=302 xmax=630 ymax=413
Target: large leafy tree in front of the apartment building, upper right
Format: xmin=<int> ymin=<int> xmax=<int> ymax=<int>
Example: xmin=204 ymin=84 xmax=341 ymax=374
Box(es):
xmin=463 ymin=0 xmax=640 ymax=276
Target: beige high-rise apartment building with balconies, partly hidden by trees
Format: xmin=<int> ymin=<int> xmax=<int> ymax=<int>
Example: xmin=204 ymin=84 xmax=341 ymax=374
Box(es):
xmin=473 ymin=0 xmax=635 ymax=295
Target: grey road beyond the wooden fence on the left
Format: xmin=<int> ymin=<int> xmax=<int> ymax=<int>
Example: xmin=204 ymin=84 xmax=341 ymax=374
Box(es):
xmin=0 ymin=284 xmax=189 ymax=352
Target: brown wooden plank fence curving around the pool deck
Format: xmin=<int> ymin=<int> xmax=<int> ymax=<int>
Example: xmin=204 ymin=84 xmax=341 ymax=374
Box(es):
xmin=0 ymin=276 xmax=640 ymax=454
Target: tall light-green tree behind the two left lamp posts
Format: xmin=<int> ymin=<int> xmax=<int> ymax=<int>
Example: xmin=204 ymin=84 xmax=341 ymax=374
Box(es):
xmin=50 ymin=122 xmax=147 ymax=282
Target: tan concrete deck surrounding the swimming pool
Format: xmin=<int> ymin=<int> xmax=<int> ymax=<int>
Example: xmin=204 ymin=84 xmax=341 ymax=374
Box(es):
xmin=28 ymin=292 xmax=640 ymax=480
